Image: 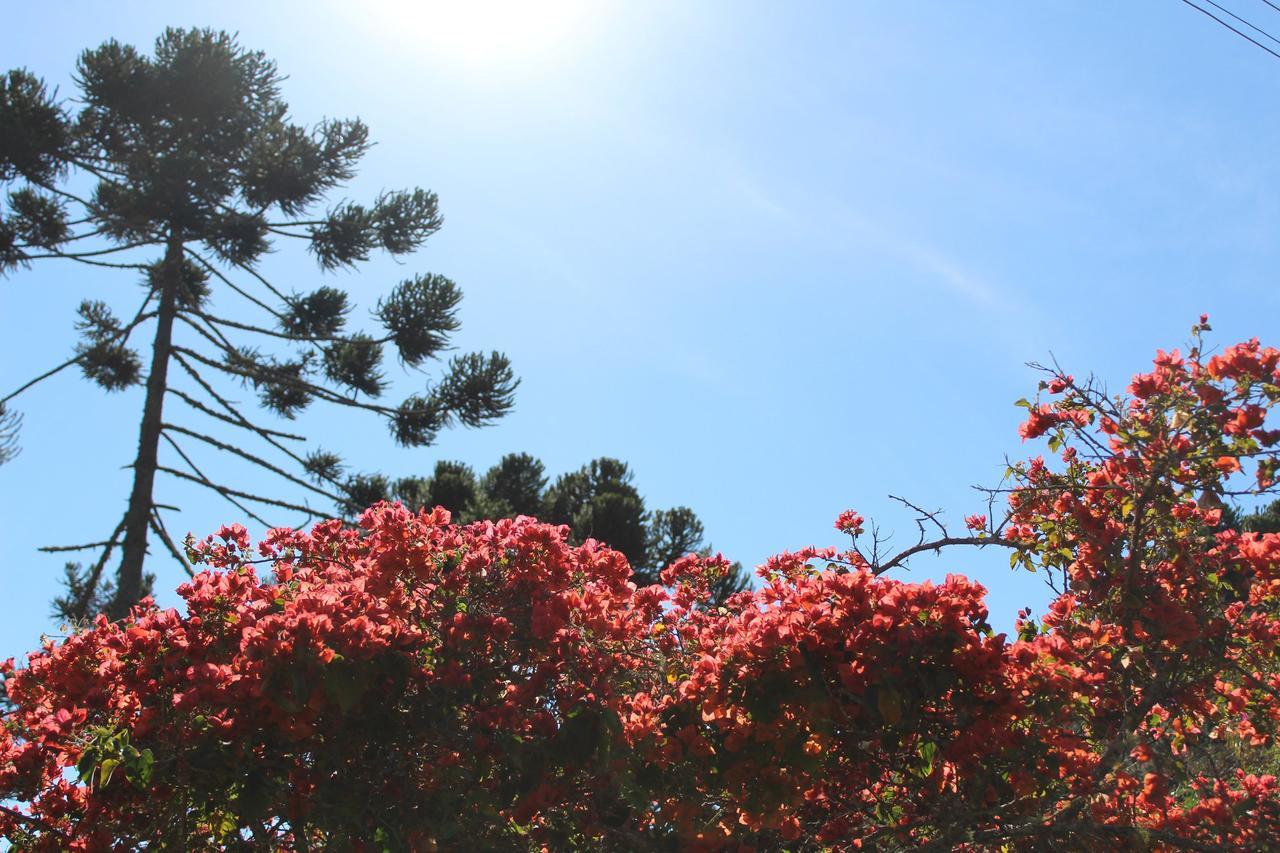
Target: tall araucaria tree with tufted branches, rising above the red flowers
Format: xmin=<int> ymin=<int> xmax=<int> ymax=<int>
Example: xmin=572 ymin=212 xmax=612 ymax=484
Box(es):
xmin=0 ymin=29 xmax=516 ymax=616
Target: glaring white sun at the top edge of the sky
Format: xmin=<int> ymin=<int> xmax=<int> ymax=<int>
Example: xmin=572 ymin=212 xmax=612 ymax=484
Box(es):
xmin=362 ymin=0 xmax=591 ymax=69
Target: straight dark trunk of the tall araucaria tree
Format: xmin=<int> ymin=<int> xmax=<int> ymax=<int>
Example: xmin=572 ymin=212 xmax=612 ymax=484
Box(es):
xmin=108 ymin=231 xmax=183 ymax=619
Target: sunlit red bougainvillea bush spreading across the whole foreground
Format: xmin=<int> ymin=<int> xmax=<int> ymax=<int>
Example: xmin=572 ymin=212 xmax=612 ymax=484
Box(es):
xmin=0 ymin=320 xmax=1280 ymax=850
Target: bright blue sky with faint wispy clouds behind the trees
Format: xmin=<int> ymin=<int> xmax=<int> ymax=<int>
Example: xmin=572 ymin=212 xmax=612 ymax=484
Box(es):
xmin=0 ymin=0 xmax=1280 ymax=657
